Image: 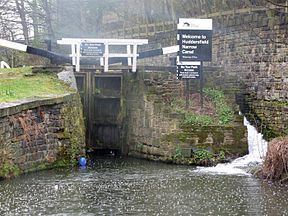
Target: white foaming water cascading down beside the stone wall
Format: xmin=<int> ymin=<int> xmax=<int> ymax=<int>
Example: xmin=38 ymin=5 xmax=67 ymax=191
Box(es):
xmin=194 ymin=117 xmax=268 ymax=175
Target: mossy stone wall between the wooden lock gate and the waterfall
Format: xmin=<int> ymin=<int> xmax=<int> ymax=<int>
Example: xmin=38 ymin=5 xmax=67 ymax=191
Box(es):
xmin=122 ymin=72 xmax=248 ymax=163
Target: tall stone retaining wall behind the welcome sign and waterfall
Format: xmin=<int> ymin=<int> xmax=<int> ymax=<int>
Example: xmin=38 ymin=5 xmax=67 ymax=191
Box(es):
xmin=134 ymin=7 xmax=288 ymax=139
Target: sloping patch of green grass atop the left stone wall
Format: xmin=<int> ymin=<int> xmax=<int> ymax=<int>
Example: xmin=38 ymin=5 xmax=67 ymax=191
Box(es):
xmin=0 ymin=67 xmax=72 ymax=102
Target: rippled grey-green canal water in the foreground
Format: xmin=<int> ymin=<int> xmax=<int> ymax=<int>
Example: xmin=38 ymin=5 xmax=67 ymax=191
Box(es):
xmin=0 ymin=158 xmax=288 ymax=216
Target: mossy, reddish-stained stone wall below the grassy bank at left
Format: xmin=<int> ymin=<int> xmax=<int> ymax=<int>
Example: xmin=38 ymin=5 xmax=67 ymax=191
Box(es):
xmin=0 ymin=94 xmax=85 ymax=175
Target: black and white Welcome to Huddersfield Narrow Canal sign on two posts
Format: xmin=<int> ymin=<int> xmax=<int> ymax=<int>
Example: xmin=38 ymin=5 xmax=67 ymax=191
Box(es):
xmin=177 ymin=18 xmax=213 ymax=109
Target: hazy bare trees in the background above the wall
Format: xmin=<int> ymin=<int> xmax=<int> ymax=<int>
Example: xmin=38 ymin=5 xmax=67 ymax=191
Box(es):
xmin=0 ymin=0 xmax=286 ymax=67
